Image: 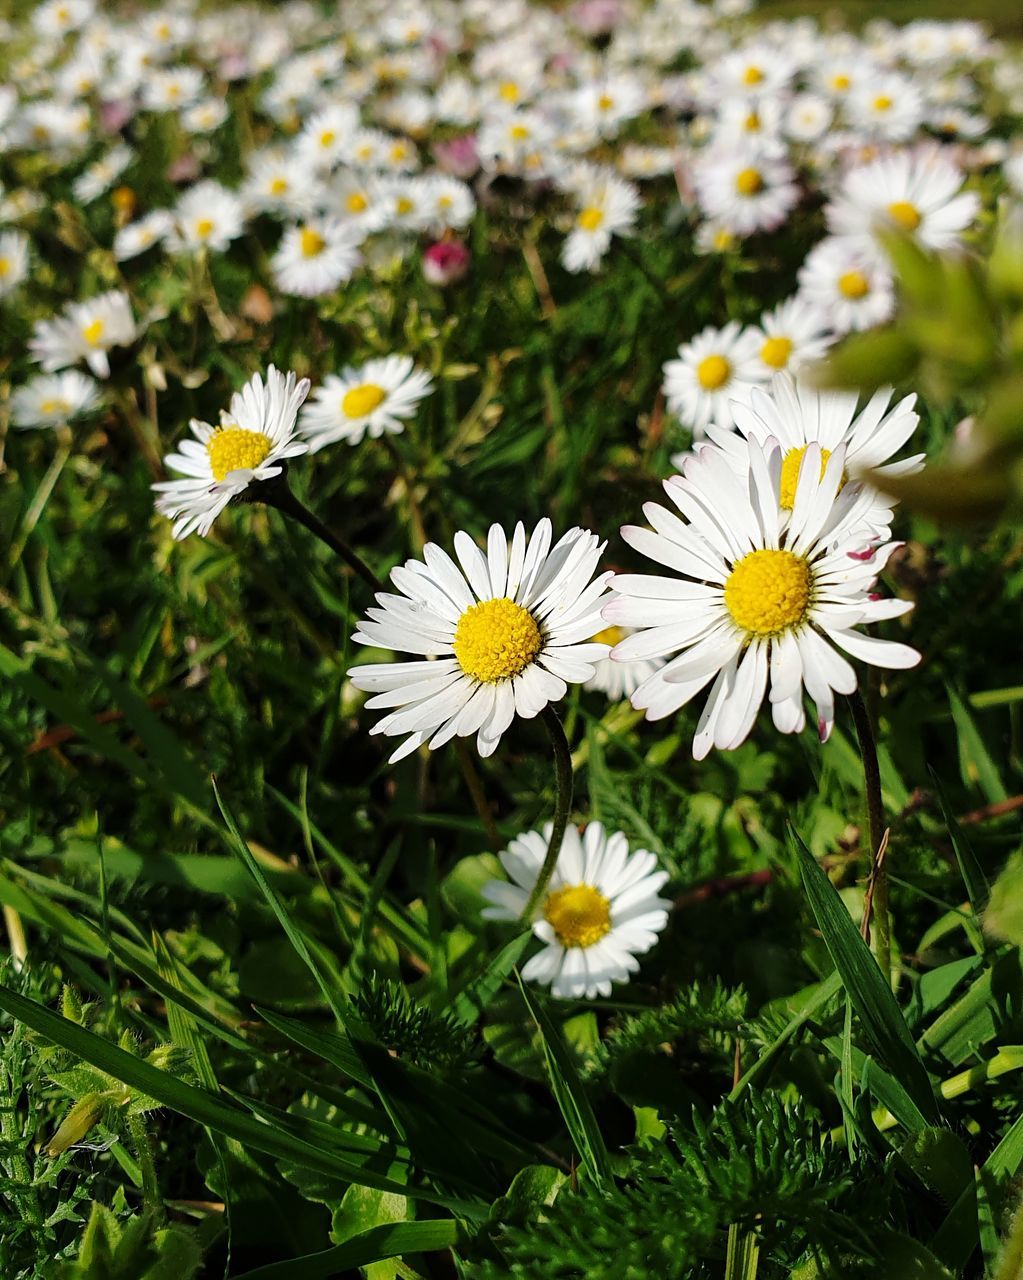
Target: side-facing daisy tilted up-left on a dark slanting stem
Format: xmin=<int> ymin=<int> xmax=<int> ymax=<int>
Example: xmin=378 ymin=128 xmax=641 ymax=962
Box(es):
xmin=152 ymin=365 xmax=309 ymax=539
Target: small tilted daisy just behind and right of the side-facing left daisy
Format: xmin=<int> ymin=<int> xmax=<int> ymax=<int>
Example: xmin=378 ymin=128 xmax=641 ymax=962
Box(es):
xmin=298 ymin=356 xmax=433 ymax=453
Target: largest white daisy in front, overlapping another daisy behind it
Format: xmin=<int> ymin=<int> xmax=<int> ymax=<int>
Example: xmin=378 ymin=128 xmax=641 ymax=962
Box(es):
xmin=603 ymin=440 xmax=919 ymax=760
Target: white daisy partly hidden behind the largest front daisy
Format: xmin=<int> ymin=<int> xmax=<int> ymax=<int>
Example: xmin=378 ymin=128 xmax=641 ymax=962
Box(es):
xmin=706 ymin=374 xmax=924 ymax=541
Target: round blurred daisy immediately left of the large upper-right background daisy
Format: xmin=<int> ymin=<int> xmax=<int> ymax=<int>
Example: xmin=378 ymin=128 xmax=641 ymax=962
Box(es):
xmin=694 ymin=147 xmax=799 ymax=236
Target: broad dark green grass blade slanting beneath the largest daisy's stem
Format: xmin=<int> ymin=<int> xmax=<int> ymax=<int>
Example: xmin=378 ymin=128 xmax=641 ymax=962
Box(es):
xmin=790 ymin=828 xmax=938 ymax=1124
